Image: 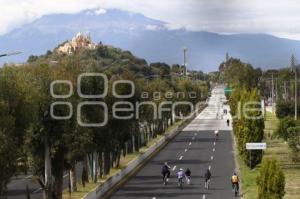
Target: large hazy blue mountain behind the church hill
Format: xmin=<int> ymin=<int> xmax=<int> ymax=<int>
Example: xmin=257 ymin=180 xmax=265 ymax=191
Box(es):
xmin=0 ymin=9 xmax=300 ymax=71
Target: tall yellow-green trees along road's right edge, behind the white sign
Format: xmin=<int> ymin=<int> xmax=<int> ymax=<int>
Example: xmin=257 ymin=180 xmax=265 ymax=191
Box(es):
xmin=220 ymin=58 xmax=264 ymax=169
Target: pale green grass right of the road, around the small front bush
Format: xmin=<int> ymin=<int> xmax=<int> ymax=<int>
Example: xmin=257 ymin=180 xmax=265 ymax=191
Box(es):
xmin=237 ymin=112 xmax=300 ymax=199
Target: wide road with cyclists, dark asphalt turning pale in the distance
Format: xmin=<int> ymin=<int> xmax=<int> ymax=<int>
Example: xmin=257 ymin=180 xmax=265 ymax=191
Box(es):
xmin=111 ymin=87 xmax=235 ymax=199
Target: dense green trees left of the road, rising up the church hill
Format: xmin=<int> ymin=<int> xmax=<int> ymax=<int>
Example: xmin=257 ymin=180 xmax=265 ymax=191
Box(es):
xmin=0 ymin=46 xmax=208 ymax=199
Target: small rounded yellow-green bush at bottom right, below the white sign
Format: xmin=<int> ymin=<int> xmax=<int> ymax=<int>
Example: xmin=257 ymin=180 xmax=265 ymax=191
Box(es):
xmin=256 ymin=159 xmax=285 ymax=199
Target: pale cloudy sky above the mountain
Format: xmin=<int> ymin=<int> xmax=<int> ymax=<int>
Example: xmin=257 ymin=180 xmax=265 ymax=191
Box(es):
xmin=0 ymin=0 xmax=300 ymax=40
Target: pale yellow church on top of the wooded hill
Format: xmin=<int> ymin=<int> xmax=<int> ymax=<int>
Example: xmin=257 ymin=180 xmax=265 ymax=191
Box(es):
xmin=56 ymin=32 xmax=98 ymax=54
